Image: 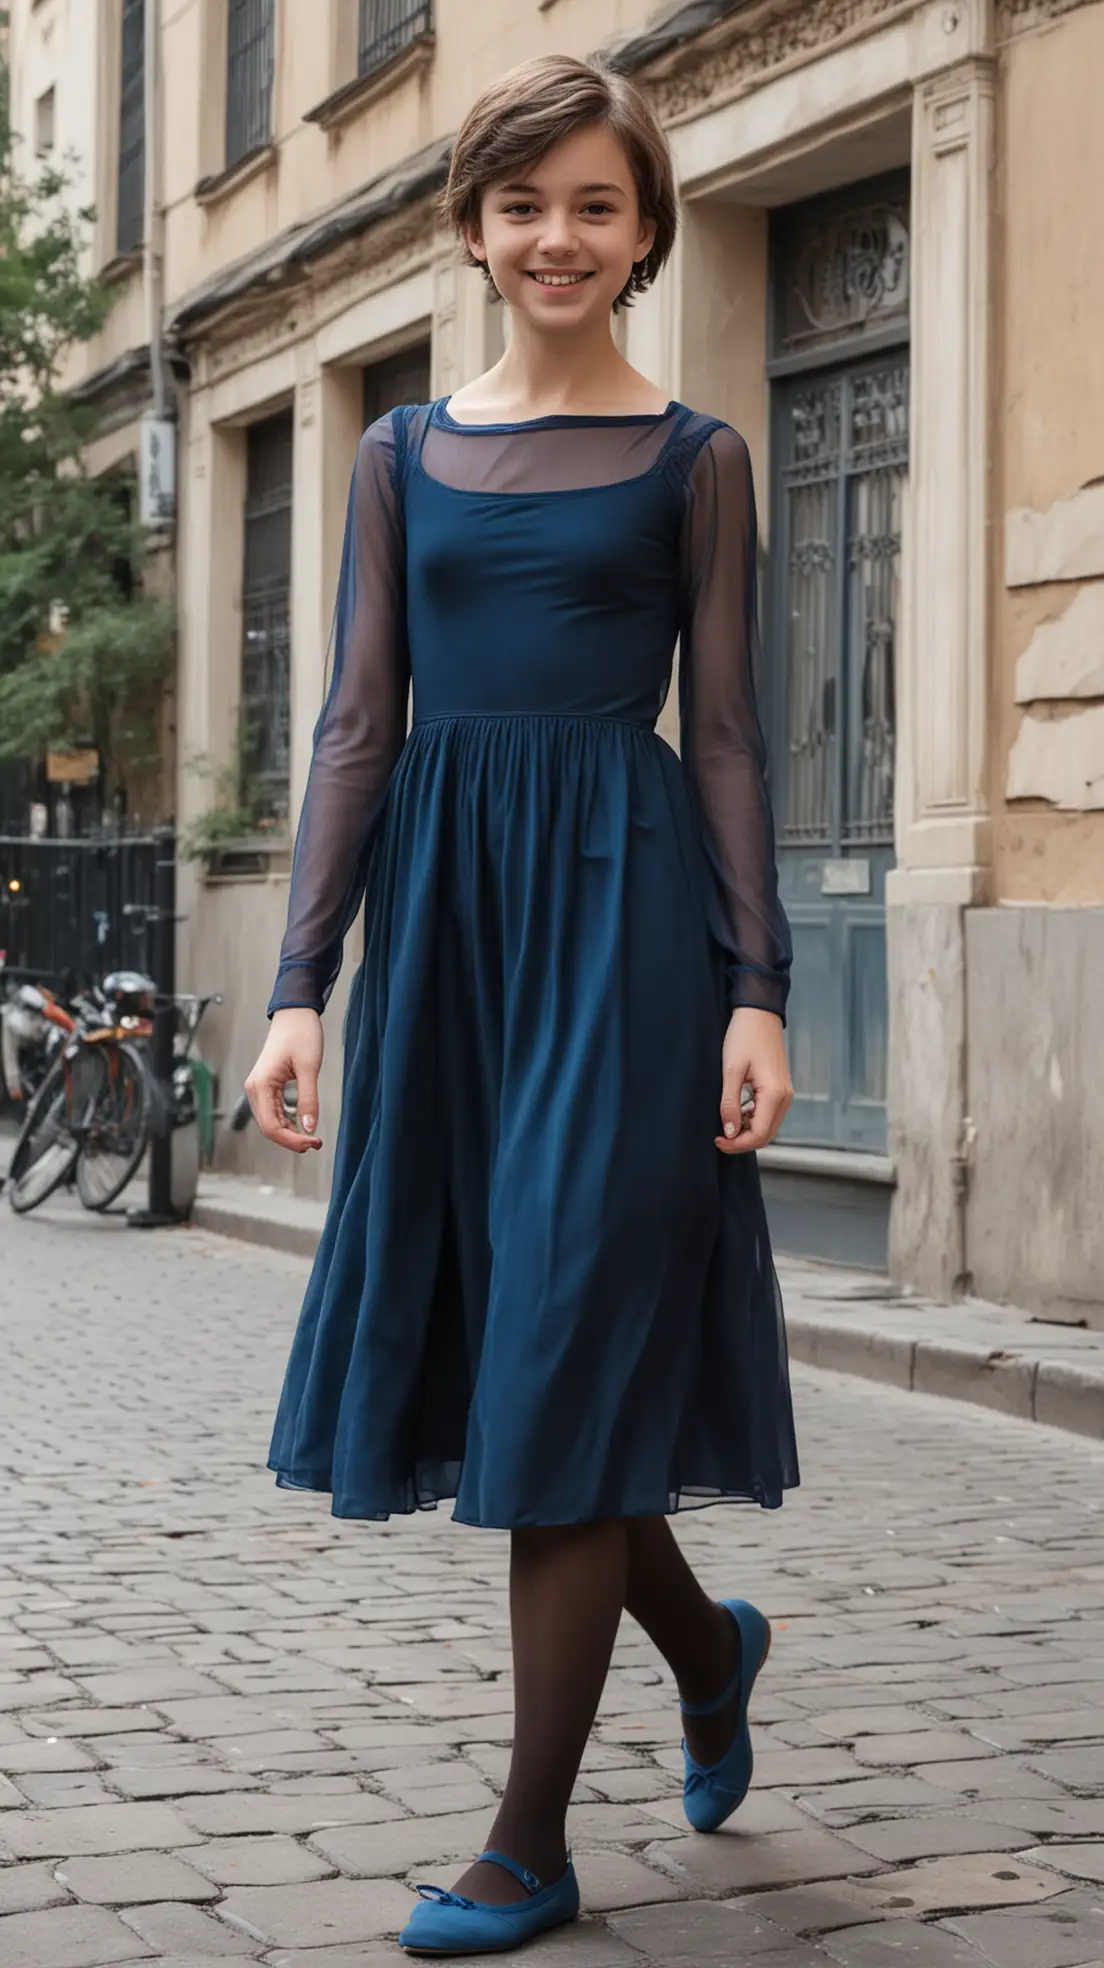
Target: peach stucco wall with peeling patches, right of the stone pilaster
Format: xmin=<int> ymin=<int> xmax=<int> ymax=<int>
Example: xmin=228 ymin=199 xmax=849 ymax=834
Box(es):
xmin=990 ymin=4 xmax=1104 ymax=903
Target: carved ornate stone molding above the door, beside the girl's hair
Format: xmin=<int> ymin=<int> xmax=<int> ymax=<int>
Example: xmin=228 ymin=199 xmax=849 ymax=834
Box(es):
xmin=636 ymin=0 xmax=917 ymax=124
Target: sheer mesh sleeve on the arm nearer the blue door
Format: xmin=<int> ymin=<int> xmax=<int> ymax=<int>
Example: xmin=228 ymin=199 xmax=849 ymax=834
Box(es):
xmin=679 ymin=425 xmax=791 ymax=1021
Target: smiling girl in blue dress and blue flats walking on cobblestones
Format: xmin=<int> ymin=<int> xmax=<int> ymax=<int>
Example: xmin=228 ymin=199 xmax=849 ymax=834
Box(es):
xmin=250 ymin=57 xmax=797 ymax=1952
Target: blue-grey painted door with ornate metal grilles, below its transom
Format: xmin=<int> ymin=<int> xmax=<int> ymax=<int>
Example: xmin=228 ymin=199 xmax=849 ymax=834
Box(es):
xmin=767 ymin=366 xmax=909 ymax=1151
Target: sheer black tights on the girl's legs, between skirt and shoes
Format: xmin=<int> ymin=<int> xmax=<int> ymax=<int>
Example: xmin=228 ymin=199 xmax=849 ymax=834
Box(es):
xmin=457 ymin=1517 xmax=738 ymax=1905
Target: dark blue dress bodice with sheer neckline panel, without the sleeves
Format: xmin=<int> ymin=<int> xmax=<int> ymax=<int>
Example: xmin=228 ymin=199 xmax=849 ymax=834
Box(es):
xmin=405 ymin=407 xmax=685 ymax=724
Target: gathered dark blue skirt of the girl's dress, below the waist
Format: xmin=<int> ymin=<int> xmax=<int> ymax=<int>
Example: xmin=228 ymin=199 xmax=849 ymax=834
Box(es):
xmin=270 ymin=712 xmax=799 ymax=1527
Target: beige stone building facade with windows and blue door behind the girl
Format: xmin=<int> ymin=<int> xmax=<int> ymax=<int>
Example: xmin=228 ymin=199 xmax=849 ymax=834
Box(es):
xmin=12 ymin=0 xmax=1104 ymax=1322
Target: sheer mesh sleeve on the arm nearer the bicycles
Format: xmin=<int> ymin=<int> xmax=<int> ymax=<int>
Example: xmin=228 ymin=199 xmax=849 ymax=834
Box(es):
xmin=268 ymin=415 xmax=409 ymax=1017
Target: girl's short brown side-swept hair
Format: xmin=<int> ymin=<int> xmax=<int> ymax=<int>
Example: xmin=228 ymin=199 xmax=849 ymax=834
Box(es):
xmin=441 ymin=55 xmax=679 ymax=309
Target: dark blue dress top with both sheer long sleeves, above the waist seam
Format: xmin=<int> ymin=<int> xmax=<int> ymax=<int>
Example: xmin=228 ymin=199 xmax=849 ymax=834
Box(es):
xmin=270 ymin=401 xmax=789 ymax=1015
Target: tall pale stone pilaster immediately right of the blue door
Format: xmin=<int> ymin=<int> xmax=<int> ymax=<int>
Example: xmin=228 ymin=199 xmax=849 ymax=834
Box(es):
xmin=886 ymin=59 xmax=994 ymax=1297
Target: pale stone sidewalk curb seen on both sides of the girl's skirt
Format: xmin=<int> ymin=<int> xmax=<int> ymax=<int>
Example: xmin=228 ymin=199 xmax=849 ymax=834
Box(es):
xmin=193 ymin=1175 xmax=1104 ymax=1441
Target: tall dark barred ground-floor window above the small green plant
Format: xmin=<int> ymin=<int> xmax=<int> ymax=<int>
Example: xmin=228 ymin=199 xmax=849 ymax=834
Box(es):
xmin=240 ymin=411 xmax=291 ymax=819
